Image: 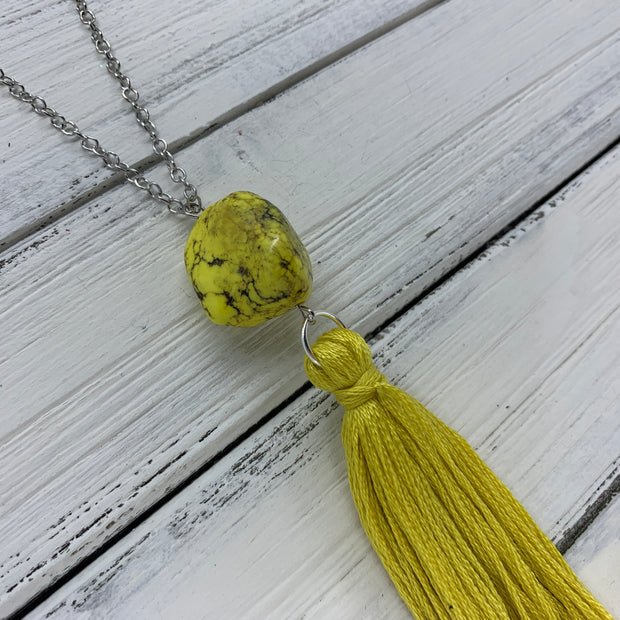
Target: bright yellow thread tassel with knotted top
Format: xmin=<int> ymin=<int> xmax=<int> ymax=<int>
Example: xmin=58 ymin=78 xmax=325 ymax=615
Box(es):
xmin=306 ymin=328 xmax=613 ymax=620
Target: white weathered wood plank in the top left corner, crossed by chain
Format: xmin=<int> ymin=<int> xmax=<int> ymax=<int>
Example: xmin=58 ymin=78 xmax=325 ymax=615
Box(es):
xmin=0 ymin=0 xmax=434 ymax=248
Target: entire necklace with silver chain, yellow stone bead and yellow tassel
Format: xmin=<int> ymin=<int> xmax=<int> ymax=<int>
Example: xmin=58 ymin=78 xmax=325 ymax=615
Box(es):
xmin=0 ymin=0 xmax=611 ymax=620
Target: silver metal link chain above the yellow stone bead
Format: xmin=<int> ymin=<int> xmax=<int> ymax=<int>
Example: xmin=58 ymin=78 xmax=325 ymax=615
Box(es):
xmin=0 ymin=0 xmax=202 ymax=217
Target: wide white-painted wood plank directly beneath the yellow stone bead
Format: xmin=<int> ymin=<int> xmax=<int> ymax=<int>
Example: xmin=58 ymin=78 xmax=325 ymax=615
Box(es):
xmin=0 ymin=0 xmax=620 ymax=611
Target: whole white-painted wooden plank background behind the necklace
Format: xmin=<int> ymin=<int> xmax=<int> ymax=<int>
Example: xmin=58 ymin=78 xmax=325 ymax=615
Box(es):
xmin=0 ymin=0 xmax=620 ymax=619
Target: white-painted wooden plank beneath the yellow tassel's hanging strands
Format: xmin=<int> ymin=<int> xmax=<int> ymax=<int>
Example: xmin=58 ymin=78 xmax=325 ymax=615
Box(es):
xmin=31 ymin=148 xmax=620 ymax=620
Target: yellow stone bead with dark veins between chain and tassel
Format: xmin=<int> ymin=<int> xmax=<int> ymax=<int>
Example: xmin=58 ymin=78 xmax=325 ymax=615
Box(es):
xmin=185 ymin=192 xmax=312 ymax=327
